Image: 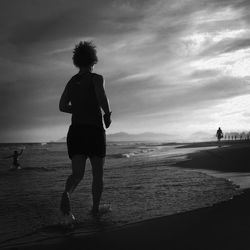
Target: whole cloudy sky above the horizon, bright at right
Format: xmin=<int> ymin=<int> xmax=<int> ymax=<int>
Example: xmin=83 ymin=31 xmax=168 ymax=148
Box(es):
xmin=0 ymin=0 xmax=250 ymax=142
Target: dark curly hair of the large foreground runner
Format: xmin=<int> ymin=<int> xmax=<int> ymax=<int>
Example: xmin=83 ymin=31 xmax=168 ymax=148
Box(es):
xmin=72 ymin=41 xmax=98 ymax=68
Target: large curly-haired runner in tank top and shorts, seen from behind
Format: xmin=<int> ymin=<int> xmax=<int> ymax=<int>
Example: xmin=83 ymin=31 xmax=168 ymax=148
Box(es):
xmin=59 ymin=41 xmax=111 ymax=227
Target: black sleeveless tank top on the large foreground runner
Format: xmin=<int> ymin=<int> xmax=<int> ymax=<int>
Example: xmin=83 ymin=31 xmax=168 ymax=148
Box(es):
xmin=68 ymin=72 xmax=103 ymax=128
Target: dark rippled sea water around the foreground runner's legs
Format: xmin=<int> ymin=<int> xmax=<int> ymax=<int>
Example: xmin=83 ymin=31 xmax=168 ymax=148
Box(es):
xmin=0 ymin=142 xmax=238 ymax=248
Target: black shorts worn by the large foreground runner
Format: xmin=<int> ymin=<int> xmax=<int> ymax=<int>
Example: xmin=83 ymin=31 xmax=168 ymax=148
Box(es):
xmin=67 ymin=124 xmax=106 ymax=159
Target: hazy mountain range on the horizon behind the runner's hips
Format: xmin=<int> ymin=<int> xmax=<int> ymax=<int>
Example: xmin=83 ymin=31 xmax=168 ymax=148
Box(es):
xmin=56 ymin=132 xmax=174 ymax=142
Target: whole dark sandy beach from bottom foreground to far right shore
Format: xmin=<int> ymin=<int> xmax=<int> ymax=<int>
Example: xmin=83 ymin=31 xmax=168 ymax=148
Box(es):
xmin=1 ymin=141 xmax=250 ymax=250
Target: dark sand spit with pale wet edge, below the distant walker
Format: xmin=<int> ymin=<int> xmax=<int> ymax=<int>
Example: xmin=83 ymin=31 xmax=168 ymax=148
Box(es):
xmin=173 ymin=141 xmax=250 ymax=190
